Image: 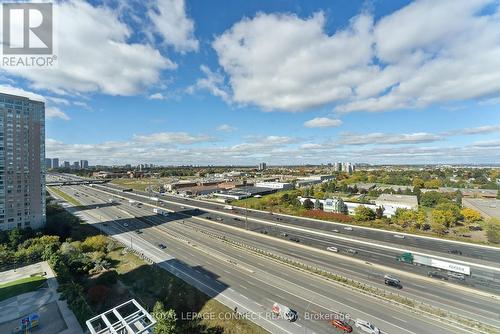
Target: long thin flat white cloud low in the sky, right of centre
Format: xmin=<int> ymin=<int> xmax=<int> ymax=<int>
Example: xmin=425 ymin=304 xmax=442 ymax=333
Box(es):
xmin=338 ymin=132 xmax=443 ymax=145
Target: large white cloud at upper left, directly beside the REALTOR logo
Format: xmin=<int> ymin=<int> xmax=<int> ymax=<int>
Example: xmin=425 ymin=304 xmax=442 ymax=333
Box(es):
xmin=3 ymin=0 xmax=176 ymax=95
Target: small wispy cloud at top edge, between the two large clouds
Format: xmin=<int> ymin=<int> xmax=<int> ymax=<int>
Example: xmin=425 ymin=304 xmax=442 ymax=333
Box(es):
xmin=148 ymin=0 xmax=198 ymax=52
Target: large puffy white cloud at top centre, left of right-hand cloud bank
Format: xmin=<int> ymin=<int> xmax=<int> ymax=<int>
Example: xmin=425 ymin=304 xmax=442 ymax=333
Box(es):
xmin=213 ymin=13 xmax=372 ymax=111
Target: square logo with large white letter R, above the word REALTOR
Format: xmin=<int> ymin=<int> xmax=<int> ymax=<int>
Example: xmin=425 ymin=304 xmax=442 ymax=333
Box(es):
xmin=2 ymin=3 xmax=53 ymax=55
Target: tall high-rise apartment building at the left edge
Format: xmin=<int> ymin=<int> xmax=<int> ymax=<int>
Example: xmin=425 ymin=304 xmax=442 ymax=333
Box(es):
xmin=0 ymin=93 xmax=46 ymax=230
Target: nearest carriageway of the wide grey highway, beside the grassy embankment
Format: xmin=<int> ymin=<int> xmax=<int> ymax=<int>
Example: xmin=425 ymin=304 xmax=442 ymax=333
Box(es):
xmin=51 ymin=187 xmax=500 ymax=333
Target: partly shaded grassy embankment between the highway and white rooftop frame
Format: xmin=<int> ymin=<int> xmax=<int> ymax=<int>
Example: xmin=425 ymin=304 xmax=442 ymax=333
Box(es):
xmin=51 ymin=189 xmax=267 ymax=334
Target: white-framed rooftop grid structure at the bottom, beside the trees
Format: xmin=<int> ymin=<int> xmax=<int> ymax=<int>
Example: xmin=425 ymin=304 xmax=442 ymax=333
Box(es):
xmin=86 ymin=299 xmax=156 ymax=334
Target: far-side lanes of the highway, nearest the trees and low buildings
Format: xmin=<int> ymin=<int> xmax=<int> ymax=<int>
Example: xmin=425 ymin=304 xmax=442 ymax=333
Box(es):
xmin=95 ymin=181 xmax=500 ymax=294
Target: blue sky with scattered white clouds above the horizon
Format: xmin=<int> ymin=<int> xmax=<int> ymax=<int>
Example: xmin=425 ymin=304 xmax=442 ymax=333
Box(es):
xmin=0 ymin=0 xmax=500 ymax=165
